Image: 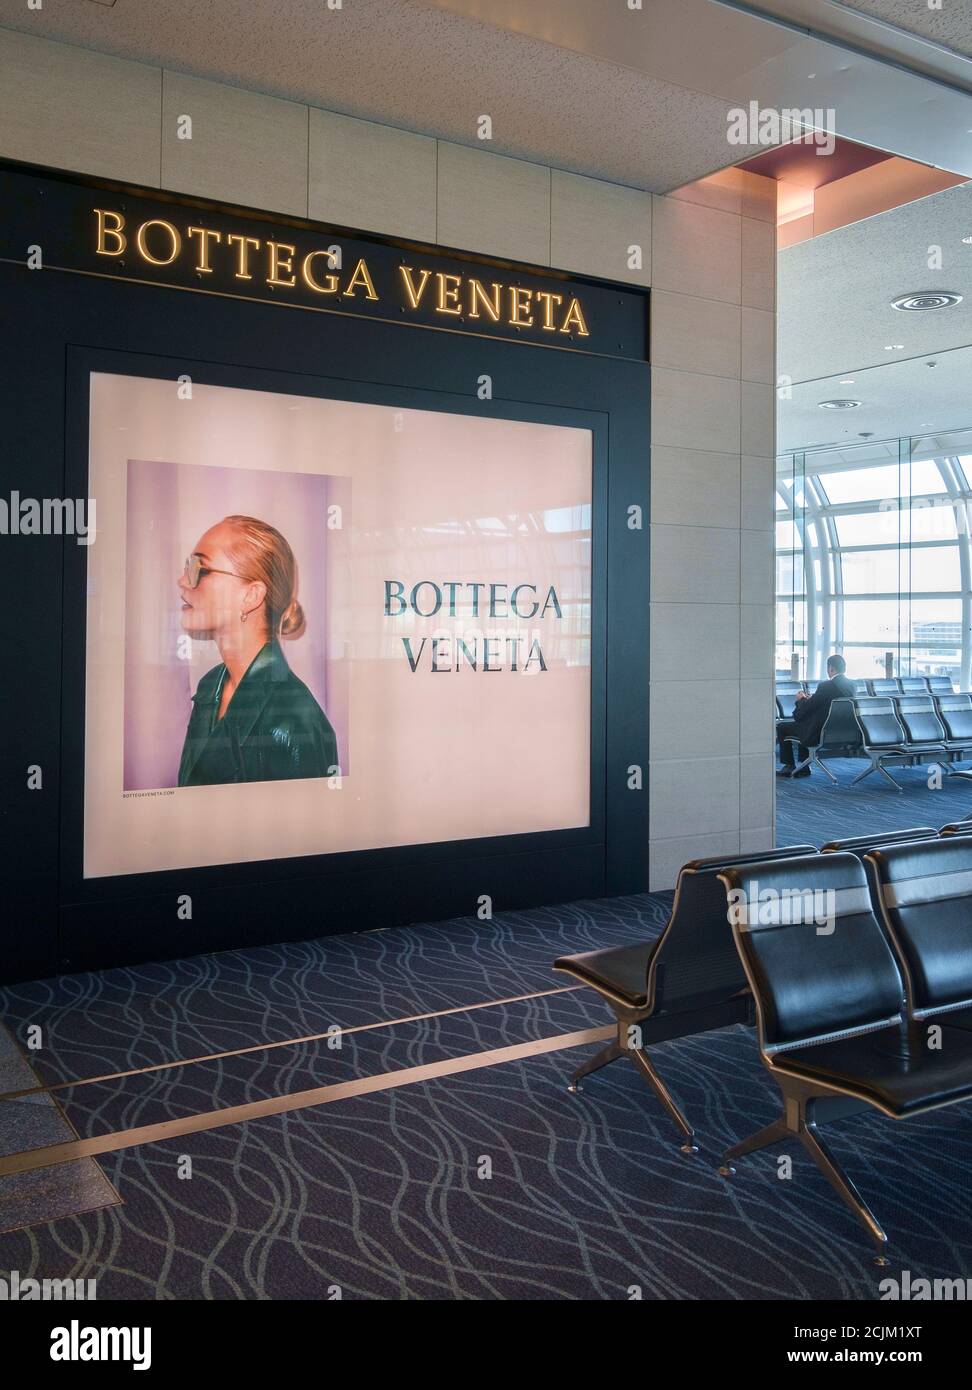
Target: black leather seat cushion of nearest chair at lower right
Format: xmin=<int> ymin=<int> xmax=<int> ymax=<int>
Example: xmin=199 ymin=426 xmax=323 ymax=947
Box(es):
xmin=773 ymin=1017 xmax=972 ymax=1115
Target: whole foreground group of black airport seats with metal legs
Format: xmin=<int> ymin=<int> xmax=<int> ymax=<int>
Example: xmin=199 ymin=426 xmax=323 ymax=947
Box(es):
xmin=553 ymin=819 xmax=972 ymax=1264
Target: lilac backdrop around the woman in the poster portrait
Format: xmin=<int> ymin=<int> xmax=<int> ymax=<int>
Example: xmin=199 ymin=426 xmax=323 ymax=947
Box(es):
xmin=124 ymin=459 xmax=350 ymax=791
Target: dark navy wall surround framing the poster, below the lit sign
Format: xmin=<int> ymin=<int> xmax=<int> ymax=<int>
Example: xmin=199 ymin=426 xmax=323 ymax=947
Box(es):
xmin=0 ymin=168 xmax=649 ymax=981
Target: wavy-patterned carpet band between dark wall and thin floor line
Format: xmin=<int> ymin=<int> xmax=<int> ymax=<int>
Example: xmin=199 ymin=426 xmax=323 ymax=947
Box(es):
xmin=0 ymin=894 xmax=672 ymax=1083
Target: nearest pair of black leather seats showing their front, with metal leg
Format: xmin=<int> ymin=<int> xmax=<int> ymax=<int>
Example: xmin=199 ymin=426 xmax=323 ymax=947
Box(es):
xmin=720 ymin=837 xmax=972 ymax=1264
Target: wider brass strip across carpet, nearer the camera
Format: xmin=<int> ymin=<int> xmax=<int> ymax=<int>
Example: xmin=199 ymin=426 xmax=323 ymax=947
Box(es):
xmin=0 ymin=1023 xmax=617 ymax=1177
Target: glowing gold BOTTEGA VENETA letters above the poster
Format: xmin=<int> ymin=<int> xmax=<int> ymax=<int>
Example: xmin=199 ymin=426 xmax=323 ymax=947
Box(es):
xmin=92 ymin=207 xmax=591 ymax=338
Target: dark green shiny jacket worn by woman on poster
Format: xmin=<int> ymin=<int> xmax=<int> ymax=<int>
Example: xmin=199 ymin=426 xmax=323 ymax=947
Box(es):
xmin=179 ymin=642 xmax=338 ymax=787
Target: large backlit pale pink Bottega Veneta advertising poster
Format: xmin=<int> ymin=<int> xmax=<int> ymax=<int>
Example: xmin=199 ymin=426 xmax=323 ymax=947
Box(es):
xmin=85 ymin=373 xmax=591 ymax=877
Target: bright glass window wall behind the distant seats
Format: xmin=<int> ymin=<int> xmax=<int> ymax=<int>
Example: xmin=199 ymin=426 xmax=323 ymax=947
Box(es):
xmin=776 ymin=430 xmax=972 ymax=689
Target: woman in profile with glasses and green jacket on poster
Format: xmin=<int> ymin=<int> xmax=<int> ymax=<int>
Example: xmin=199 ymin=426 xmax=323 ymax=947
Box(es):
xmin=178 ymin=516 xmax=338 ymax=787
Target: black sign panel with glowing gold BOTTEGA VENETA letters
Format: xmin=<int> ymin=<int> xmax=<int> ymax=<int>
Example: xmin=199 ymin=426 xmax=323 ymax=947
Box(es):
xmin=0 ymin=168 xmax=648 ymax=361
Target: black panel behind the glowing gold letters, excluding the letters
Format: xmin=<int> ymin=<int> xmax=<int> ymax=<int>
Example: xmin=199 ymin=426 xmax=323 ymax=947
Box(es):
xmin=0 ymin=160 xmax=649 ymax=361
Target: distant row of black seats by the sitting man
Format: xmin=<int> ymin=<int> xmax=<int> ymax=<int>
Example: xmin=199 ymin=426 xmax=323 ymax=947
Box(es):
xmin=787 ymin=694 xmax=972 ymax=791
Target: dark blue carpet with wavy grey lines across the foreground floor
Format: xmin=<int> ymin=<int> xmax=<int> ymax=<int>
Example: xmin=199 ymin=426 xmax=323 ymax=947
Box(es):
xmin=0 ymin=884 xmax=972 ymax=1300
